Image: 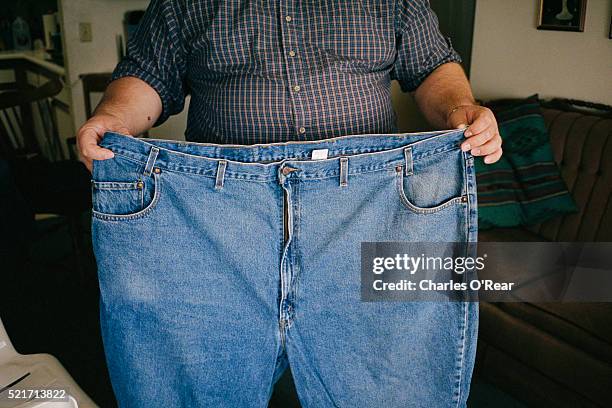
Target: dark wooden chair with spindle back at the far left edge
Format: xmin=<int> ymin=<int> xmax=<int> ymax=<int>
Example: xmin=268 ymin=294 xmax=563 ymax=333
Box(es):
xmin=0 ymin=80 xmax=91 ymax=275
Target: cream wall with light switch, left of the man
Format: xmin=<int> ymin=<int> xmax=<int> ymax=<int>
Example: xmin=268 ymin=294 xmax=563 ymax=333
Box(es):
xmin=59 ymin=0 xmax=187 ymax=139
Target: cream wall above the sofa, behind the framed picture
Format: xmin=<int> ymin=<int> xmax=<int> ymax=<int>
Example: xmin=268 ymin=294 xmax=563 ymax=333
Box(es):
xmin=471 ymin=0 xmax=612 ymax=105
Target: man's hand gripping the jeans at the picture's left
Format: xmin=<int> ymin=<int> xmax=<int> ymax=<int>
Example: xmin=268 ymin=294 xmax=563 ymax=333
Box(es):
xmin=77 ymin=113 xmax=130 ymax=172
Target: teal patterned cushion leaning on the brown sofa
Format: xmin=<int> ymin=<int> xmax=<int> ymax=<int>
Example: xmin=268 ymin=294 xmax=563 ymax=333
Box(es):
xmin=475 ymin=96 xmax=576 ymax=230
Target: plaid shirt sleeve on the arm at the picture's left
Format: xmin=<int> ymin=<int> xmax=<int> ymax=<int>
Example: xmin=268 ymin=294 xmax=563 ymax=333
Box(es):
xmin=111 ymin=0 xmax=187 ymax=126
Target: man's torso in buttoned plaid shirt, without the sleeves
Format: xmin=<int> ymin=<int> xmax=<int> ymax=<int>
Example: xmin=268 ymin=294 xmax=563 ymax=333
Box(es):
xmin=180 ymin=0 xmax=396 ymax=144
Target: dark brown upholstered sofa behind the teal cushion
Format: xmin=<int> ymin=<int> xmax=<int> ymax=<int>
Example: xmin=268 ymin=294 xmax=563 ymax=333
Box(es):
xmin=477 ymin=100 xmax=612 ymax=407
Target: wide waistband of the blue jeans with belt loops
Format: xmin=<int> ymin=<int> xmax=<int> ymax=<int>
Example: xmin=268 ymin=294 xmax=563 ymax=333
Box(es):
xmin=100 ymin=129 xmax=465 ymax=181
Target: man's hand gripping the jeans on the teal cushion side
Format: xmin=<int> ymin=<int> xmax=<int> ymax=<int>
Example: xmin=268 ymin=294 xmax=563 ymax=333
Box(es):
xmin=447 ymin=105 xmax=502 ymax=164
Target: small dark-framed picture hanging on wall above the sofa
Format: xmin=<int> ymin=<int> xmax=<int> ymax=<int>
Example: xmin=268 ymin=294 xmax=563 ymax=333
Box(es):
xmin=538 ymin=0 xmax=587 ymax=32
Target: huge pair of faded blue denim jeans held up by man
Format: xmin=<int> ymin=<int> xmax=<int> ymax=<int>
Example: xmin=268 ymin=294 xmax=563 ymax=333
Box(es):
xmin=92 ymin=130 xmax=478 ymax=407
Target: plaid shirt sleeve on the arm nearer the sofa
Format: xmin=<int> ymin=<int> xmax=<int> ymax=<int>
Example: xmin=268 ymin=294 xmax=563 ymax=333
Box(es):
xmin=391 ymin=0 xmax=461 ymax=92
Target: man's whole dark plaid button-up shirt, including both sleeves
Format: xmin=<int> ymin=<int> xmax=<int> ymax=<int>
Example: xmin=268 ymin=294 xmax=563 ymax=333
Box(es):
xmin=113 ymin=0 xmax=460 ymax=144
